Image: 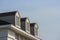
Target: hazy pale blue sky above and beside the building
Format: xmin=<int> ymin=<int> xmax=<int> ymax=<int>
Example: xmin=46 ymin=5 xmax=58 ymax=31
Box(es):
xmin=0 ymin=0 xmax=60 ymax=40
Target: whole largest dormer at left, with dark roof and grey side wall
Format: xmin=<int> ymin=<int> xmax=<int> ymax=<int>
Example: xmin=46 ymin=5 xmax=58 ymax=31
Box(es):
xmin=0 ymin=11 xmax=20 ymax=28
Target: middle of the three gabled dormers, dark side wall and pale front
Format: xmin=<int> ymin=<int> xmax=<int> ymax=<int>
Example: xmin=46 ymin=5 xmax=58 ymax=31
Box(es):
xmin=21 ymin=17 xmax=30 ymax=33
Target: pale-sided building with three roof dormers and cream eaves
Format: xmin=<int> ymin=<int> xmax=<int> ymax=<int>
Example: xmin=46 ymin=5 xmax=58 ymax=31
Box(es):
xmin=0 ymin=11 xmax=38 ymax=40
